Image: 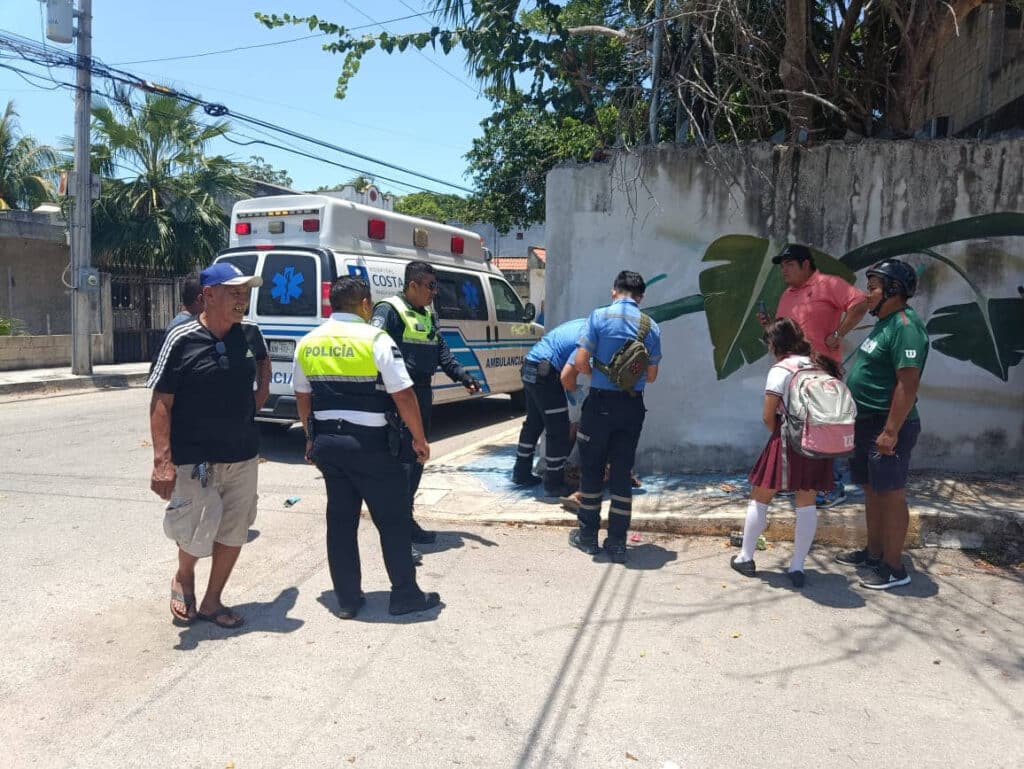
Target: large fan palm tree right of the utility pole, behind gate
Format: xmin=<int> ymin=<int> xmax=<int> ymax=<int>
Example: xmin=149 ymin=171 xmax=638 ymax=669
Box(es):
xmin=92 ymin=91 xmax=250 ymax=274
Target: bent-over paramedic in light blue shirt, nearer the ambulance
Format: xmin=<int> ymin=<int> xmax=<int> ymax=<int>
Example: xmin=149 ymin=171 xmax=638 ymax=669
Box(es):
xmin=512 ymin=317 xmax=587 ymax=497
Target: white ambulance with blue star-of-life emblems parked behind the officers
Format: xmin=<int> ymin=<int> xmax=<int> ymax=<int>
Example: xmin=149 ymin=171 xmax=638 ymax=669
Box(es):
xmin=216 ymin=195 xmax=544 ymax=424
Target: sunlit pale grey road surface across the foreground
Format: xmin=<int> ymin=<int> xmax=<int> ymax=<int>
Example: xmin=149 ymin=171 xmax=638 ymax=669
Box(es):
xmin=0 ymin=390 xmax=1024 ymax=769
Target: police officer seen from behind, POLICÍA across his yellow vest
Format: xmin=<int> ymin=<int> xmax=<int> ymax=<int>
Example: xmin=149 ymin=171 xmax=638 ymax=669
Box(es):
xmin=293 ymin=275 xmax=440 ymax=620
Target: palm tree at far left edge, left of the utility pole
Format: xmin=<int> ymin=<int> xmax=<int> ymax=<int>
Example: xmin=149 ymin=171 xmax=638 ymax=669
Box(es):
xmin=0 ymin=101 xmax=57 ymax=214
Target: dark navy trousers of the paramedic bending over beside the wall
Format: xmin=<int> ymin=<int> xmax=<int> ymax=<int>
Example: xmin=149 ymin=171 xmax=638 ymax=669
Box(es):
xmin=516 ymin=361 xmax=569 ymax=488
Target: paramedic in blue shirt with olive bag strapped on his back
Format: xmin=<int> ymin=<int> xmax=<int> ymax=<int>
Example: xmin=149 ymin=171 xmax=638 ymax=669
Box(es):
xmin=562 ymin=270 xmax=662 ymax=563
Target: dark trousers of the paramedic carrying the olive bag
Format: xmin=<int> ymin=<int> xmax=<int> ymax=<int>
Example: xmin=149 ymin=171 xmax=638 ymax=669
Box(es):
xmin=577 ymin=388 xmax=647 ymax=543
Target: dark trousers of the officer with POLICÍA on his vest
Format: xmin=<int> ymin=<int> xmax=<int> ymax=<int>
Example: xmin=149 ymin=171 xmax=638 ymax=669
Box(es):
xmin=312 ymin=423 xmax=421 ymax=606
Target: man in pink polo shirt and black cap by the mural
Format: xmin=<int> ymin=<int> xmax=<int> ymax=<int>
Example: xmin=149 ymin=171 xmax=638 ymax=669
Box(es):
xmin=758 ymin=244 xmax=867 ymax=507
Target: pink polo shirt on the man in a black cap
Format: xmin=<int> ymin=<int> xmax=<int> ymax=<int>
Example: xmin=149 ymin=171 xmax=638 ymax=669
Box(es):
xmin=775 ymin=270 xmax=867 ymax=362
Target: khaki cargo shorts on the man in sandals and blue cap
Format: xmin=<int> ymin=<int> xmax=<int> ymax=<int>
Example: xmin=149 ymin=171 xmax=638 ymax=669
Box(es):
xmin=164 ymin=457 xmax=259 ymax=558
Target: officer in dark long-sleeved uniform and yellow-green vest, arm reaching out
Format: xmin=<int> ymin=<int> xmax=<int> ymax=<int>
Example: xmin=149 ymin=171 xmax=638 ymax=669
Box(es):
xmin=371 ymin=261 xmax=480 ymax=557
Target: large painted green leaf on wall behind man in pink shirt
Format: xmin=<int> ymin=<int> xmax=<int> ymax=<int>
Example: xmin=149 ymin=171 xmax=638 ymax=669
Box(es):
xmin=699 ymin=234 xmax=854 ymax=379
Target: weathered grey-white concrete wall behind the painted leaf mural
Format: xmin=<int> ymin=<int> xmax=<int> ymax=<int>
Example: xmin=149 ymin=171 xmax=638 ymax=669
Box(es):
xmin=546 ymin=141 xmax=1024 ymax=471
